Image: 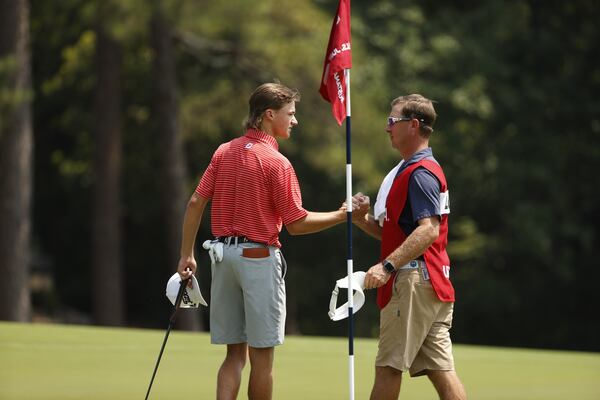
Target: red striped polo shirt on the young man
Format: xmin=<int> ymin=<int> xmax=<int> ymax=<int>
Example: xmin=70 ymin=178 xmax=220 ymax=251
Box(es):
xmin=196 ymin=129 xmax=308 ymax=247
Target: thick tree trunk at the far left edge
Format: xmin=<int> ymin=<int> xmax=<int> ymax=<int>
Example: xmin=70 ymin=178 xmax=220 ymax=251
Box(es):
xmin=0 ymin=0 xmax=33 ymax=321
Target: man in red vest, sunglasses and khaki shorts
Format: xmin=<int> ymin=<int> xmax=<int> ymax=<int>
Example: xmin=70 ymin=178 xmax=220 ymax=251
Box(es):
xmin=355 ymin=94 xmax=466 ymax=400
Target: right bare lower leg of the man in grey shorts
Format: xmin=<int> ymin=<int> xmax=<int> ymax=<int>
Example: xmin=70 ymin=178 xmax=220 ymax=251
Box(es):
xmin=248 ymin=347 xmax=275 ymax=400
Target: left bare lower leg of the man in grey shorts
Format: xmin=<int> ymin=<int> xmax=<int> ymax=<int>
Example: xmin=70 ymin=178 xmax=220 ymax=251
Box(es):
xmin=217 ymin=343 xmax=248 ymax=400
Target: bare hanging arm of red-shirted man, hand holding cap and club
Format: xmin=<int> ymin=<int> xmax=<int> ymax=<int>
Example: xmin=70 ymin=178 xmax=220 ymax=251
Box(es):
xmin=177 ymin=193 xmax=209 ymax=279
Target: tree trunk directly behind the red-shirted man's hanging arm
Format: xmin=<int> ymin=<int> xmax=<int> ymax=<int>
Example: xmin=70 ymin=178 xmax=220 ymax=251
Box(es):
xmin=150 ymin=10 xmax=203 ymax=330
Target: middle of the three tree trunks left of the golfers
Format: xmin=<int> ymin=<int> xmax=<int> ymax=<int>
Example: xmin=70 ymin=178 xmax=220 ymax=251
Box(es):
xmin=91 ymin=24 xmax=125 ymax=326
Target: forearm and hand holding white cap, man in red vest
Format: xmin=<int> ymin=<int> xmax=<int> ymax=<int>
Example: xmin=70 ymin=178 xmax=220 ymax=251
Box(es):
xmin=365 ymin=216 xmax=440 ymax=289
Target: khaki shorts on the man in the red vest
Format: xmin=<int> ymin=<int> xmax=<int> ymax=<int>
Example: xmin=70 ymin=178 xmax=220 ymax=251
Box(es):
xmin=375 ymin=267 xmax=454 ymax=376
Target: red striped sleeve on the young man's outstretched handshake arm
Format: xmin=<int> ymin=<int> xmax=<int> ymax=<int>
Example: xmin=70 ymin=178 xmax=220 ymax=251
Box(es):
xmin=271 ymin=164 xmax=308 ymax=225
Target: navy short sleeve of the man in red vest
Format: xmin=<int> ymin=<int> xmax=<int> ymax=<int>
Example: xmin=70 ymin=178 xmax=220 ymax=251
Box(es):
xmin=408 ymin=167 xmax=441 ymax=223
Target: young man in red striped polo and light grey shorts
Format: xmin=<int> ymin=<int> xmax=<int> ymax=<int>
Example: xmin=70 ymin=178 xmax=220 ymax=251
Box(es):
xmin=178 ymin=83 xmax=368 ymax=400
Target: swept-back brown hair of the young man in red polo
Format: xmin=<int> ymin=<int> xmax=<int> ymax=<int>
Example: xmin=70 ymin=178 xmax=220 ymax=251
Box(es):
xmin=244 ymin=83 xmax=300 ymax=129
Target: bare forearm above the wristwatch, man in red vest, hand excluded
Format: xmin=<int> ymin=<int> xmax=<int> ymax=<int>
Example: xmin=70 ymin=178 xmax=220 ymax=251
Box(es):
xmin=387 ymin=217 xmax=440 ymax=268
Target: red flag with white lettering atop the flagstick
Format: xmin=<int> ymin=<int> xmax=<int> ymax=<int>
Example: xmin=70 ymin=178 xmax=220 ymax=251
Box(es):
xmin=319 ymin=0 xmax=352 ymax=125
